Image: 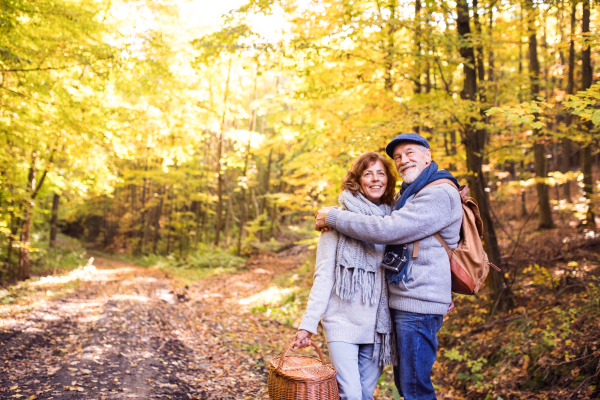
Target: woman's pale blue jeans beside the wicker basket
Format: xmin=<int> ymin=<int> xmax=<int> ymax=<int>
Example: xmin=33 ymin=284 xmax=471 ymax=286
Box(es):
xmin=327 ymin=342 xmax=383 ymax=400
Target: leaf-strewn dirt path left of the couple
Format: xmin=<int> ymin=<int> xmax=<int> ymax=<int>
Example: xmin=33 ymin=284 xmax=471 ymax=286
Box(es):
xmin=0 ymin=256 xmax=308 ymax=400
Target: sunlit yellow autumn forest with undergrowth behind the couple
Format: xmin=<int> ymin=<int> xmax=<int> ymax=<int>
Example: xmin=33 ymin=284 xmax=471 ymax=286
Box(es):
xmin=0 ymin=0 xmax=600 ymax=398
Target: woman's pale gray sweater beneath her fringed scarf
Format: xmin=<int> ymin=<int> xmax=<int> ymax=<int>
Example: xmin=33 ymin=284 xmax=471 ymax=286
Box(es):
xmin=298 ymin=223 xmax=385 ymax=344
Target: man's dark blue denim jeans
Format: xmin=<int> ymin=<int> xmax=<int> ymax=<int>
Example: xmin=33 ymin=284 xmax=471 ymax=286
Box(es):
xmin=391 ymin=309 xmax=444 ymax=400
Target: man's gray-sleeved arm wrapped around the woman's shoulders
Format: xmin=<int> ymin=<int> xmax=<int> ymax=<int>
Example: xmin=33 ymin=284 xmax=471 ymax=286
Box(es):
xmin=326 ymin=184 xmax=461 ymax=244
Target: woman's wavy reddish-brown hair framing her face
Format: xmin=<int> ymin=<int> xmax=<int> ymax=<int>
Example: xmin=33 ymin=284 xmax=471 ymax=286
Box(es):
xmin=341 ymin=151 xmax=396 ymax=205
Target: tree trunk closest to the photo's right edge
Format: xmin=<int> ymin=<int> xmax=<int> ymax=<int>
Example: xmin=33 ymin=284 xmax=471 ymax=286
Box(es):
xmin=581 ymin=0 xmax=596 ymax=229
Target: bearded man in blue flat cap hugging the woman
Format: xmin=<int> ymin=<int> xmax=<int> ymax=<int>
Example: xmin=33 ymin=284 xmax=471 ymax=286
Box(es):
xmin=316 ymin=133 xmax=462 ymax=400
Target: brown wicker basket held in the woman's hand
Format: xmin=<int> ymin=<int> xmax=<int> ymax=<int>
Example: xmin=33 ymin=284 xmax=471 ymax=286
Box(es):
xmin=269 ymin=343 xmax=340 ymax=400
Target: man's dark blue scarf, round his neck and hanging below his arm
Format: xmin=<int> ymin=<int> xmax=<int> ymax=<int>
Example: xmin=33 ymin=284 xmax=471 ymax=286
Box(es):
xmin=385 ymin=161 xmax=459 ymax=285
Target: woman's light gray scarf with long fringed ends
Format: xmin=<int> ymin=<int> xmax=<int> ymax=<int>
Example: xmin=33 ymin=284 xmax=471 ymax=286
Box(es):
xmin=335 ymin=190 xmax=397 ymax=366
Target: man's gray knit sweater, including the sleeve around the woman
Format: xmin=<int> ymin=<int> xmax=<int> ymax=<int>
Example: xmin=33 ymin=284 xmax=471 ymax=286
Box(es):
xmin=326 ymin=183 xmax=462 ymax=315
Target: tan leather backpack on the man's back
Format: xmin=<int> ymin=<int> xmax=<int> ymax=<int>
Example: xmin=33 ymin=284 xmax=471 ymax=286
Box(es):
xmin=413 ymin=179 xmax=500 ymax=295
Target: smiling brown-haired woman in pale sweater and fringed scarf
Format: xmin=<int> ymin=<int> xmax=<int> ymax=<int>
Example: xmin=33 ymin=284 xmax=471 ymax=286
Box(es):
xmin=293 ymin=152 xmax=396 ymax=400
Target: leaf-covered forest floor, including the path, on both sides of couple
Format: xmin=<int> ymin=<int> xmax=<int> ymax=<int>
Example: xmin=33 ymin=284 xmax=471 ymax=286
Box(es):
xmin=0 ymin=224 xmax=600 ymax=400
